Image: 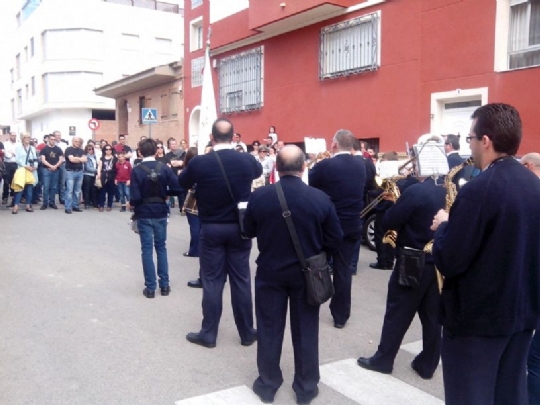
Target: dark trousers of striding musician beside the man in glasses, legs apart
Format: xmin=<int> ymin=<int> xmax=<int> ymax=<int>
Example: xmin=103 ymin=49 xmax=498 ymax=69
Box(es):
xmin=374 ymin=263 xmax=441 ymax=377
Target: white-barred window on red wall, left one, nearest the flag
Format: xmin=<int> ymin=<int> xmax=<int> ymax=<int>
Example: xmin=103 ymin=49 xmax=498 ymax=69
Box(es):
xmin=219 ymin=47 xmax=263 ymax=113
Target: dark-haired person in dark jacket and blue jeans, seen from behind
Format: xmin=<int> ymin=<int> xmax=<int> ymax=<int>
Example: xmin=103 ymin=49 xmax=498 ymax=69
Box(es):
xmin=129 ymin=139 xmax=181 ymax=298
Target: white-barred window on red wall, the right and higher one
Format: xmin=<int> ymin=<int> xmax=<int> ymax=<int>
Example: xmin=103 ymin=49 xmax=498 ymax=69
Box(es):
xmin=319 ymin=13 xmax=380 ymax=80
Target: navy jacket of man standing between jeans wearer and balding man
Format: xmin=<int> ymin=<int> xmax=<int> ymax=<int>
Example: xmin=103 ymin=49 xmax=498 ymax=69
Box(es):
xmin=178 ymin=149 xmax=262 ymax=224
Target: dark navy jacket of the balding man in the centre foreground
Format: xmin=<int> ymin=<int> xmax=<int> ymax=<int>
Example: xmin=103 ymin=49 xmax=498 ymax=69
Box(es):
xmin=244 ymin=175 xmax=342 ymax=274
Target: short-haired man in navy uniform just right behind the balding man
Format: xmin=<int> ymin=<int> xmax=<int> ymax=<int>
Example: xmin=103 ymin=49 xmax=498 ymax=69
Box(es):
xmin=309 ymin=129 xmax=366 ymax=329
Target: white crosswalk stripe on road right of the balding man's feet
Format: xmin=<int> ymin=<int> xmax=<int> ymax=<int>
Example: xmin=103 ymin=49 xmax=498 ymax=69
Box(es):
xmin=320 ymin=359 xmax=444 ymax=405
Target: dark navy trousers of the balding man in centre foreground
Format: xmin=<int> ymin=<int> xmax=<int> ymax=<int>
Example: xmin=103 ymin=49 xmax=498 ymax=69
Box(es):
xmin=255 ymin=268 xmax=320 ymax=399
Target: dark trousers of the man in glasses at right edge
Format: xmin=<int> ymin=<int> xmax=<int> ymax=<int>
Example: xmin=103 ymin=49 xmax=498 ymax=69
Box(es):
xmin=441 ymin=330 xmax=533 ymax=405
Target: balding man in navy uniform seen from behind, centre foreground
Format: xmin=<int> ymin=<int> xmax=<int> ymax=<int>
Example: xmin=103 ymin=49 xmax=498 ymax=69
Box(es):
xmin=244 ymin=145 xmax=342 ymax=404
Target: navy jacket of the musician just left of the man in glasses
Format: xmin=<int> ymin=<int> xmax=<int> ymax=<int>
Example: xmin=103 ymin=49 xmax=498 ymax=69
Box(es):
xmin=381 ymin=179 xmax=446 ymax=263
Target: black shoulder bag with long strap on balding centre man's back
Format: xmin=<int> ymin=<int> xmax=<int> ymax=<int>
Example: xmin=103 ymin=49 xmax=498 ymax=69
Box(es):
xmin=276 ymin=182 xmax=334 ymax=306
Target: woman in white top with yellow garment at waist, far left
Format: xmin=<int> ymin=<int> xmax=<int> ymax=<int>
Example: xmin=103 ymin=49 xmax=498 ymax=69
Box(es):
xmin=11 ymin=132 xmax=38 ymax=214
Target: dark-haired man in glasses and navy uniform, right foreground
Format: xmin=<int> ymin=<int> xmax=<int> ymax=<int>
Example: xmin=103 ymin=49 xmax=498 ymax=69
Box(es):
xmin=432 ymin=104 xmax=540 ymax=405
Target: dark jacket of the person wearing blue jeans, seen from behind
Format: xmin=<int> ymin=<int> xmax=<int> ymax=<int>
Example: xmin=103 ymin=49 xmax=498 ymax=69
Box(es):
xmin=129 ymin=161 xmax=182 ymax=219
